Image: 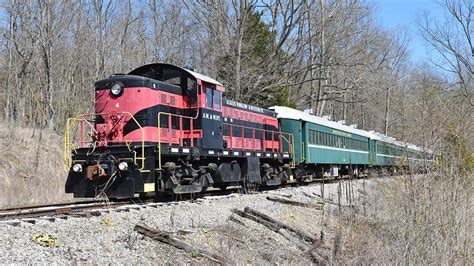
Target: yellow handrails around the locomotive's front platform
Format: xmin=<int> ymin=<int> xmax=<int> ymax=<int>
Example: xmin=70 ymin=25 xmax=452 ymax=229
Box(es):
xmin=63 ymin=112 xmax=145 ymax=172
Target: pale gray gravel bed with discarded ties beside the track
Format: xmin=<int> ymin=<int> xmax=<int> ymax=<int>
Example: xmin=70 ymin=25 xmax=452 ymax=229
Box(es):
xmin=0 ymin=179 xmax=379 ymax=264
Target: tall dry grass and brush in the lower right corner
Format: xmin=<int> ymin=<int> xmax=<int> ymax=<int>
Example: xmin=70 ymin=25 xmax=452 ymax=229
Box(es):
xmin=334 ymin=173 xmax=474 ymax=265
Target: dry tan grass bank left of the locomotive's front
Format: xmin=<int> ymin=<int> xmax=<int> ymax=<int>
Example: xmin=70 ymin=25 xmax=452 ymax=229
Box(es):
xmin=0 ymin=124 xmax=72 ymax=208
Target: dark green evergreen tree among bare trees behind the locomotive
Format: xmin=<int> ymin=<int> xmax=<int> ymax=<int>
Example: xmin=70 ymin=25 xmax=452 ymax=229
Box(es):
xmin=217 ymin=7 xmax=295 ymax=107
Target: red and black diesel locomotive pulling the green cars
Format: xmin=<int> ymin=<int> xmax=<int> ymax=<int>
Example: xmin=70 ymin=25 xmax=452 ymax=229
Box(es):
xmin=65 ymin=64 xmax=293 ymax=198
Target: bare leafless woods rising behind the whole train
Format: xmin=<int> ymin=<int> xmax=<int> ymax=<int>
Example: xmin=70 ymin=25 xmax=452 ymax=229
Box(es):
xmin=0 ymin=0 xmax=474 ymax=152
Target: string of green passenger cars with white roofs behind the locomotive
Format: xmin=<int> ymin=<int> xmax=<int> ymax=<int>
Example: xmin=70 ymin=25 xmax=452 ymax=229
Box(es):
xmin=270 ymin=106 xmax=432 ymax=177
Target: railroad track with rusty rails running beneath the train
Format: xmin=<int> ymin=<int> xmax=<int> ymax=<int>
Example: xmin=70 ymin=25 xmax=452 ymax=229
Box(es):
xmin=0 ymin=175 xmax=370 ymax=226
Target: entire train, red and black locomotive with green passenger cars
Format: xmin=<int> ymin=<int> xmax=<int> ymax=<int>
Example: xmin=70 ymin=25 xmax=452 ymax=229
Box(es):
xmin=64 ymin=63 xmax=433 ymax=199
